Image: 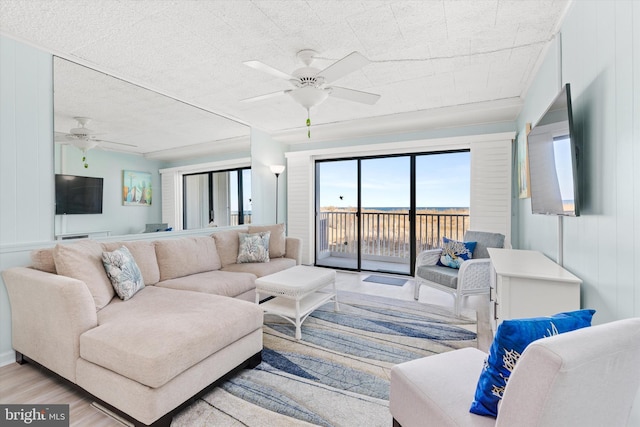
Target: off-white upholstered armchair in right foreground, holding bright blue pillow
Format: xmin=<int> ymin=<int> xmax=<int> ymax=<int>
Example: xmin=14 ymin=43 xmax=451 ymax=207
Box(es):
xmin=389 ymin=318 xmax=640 ymax=427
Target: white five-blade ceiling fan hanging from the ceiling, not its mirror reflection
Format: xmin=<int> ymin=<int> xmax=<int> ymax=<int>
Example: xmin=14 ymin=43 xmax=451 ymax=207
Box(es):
xmin=242 ymin=49 xmax=380 ymax=138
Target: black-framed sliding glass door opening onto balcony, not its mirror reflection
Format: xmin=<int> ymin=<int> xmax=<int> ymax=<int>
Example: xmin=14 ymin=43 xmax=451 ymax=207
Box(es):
xmin=316 ymin=151 xmax=470 ymax=274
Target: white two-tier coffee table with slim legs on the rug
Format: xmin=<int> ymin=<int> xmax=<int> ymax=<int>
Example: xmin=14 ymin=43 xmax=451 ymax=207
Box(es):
xmin=256 ymin=265 xmax=339 ymax=340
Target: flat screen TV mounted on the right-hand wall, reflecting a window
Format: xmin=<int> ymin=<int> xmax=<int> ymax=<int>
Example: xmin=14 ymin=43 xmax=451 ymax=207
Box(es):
xmin=527 ymin=83 xmax=580 ymax=216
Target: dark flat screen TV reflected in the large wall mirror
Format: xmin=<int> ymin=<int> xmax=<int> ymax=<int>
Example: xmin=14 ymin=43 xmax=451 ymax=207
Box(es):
xmin=56 ymin=174 xmax=103 ymax=215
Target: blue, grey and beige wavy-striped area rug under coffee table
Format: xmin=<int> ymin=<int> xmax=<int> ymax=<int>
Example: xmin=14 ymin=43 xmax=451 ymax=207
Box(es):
xmin=171 ymin=292 xmax=477 ymax=427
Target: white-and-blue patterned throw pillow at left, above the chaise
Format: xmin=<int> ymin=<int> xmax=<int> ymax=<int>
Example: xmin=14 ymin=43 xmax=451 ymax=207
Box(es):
xmin=102 ymin=246 xmax=144 ymax=301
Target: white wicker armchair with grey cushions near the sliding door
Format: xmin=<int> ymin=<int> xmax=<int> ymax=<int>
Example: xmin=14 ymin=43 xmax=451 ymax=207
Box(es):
xmin=414 ymin=230 xmax=504 ymax=316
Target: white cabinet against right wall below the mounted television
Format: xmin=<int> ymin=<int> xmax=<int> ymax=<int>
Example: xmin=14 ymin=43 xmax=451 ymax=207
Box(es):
xmin=489 ymin=248 xmax=582 ymax=331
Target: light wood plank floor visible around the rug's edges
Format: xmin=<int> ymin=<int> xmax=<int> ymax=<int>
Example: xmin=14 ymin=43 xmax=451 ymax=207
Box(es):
xmin=0 ymin=273 xmax=493 ymax=427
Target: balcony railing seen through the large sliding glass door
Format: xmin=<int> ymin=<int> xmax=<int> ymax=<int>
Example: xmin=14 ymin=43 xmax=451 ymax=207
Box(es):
xmin=318 ymin=211 xmax=469 ymax=263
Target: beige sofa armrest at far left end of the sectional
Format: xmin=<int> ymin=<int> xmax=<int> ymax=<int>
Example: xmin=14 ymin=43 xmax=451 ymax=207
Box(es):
xmin=2 ymin=267 xmax=98 ymax=383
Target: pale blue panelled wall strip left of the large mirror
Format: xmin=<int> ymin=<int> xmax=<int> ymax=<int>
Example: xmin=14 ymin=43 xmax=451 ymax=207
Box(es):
xmin=0 ymin=37 xmax=54 ymax=365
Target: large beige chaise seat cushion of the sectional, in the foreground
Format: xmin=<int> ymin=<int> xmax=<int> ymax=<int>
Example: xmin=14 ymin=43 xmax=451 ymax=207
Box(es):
xmin=80 ymin=286 xmax=263 ymax=388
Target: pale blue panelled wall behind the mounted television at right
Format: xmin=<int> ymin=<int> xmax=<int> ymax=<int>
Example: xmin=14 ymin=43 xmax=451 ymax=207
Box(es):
xmin=514 ymin=0 xmax=640 ymax=426
